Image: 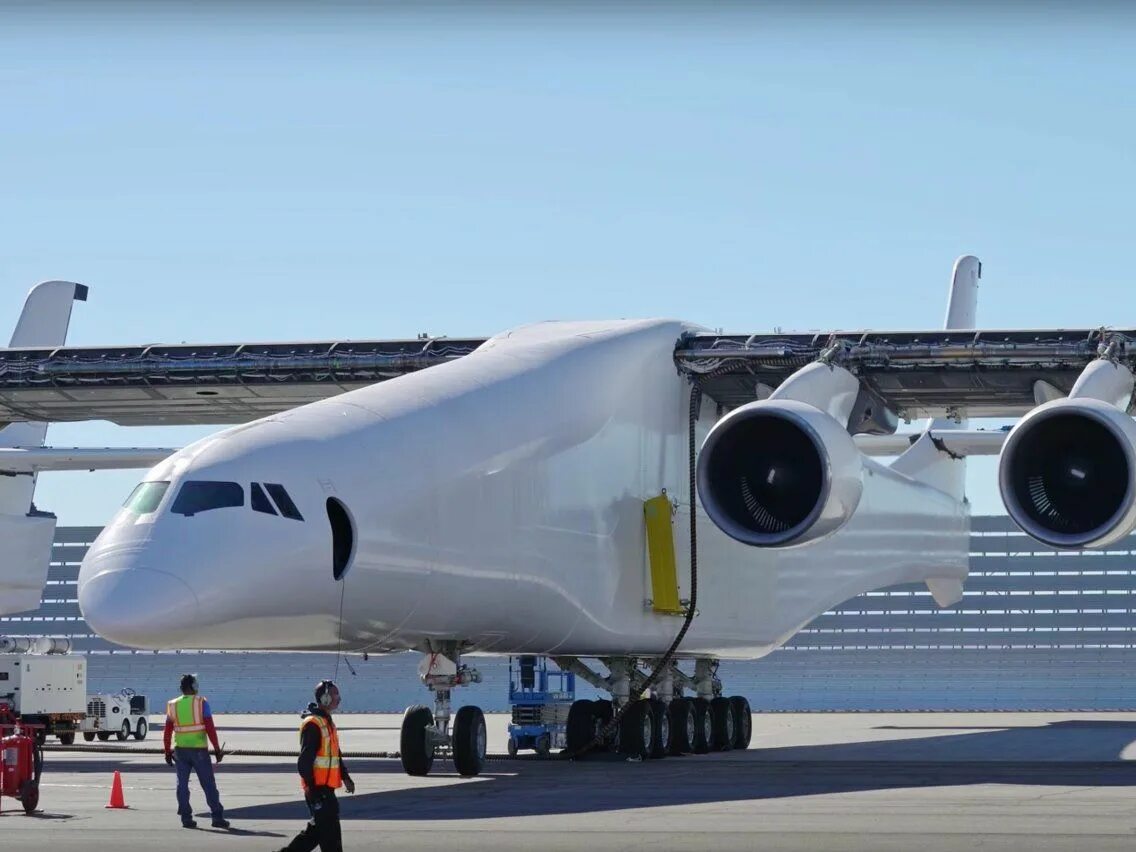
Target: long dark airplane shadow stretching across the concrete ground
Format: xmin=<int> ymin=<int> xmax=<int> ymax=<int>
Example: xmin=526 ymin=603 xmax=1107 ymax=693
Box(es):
xmin=219 ymin=721 xmax=1136 ymax=821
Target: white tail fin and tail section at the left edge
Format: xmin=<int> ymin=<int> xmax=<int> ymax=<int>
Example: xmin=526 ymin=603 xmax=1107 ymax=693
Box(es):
xmin=0 ymin=281 xmax=86 ymax=615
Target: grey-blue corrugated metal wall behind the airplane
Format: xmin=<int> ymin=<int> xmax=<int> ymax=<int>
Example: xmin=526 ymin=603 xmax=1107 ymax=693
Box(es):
xmin=0 ymin=517 xmax=1136 ymax=711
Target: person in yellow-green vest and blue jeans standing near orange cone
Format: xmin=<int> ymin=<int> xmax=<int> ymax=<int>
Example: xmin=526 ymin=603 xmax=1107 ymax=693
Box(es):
xmin=162 ymin=675 xmax=229 ymax=828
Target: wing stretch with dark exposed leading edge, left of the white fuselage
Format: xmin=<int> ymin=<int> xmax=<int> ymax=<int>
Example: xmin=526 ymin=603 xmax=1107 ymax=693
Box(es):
xmin=0 ymin=337 xmax=484 ymax=426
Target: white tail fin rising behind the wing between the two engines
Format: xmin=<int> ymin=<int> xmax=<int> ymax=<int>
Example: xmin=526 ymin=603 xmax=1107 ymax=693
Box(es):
xmin=892 ymin=254 xmax=983 ymax=501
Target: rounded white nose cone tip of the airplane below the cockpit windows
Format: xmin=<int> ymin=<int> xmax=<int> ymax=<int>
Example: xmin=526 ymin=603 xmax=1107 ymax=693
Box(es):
xmin=78 ymin=568 xmax=199 ymax=649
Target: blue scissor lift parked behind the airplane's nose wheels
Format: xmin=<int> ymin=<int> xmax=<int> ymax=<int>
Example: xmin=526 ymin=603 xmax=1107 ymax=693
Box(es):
xmin=509 ymin=657 xmax=576 ymax=754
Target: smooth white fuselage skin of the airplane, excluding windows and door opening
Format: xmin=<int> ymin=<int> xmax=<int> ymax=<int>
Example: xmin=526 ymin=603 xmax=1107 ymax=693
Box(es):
xmin=78 ymin=320 xmax=977 ymax=659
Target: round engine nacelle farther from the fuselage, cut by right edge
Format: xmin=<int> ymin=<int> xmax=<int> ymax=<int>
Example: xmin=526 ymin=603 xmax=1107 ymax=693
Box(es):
xmin=999 ymin=399 xmax=1136 ymax=549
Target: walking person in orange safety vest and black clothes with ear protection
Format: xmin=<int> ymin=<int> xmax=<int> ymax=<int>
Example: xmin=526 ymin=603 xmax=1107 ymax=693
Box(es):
xmin=283 ymin=680 xmax=354 ymax=852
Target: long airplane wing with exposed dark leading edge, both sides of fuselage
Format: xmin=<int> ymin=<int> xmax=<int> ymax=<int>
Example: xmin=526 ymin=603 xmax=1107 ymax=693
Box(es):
xmin=0 ymin=328 xmax=1122 ymax=434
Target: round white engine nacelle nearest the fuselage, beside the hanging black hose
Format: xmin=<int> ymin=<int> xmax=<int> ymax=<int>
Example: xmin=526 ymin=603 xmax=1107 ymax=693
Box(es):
xmin=698 ymin=400 xmax=863 ymax=548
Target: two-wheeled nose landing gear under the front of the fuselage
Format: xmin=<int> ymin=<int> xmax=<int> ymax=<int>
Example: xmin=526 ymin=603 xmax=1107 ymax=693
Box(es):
xmin=399 ymin=642 xmax=486 ymax=777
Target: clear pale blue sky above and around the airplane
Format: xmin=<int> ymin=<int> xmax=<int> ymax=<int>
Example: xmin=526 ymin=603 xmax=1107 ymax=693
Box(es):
xmin=0 ymin=0 xmax=1136 ymax=524
